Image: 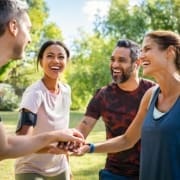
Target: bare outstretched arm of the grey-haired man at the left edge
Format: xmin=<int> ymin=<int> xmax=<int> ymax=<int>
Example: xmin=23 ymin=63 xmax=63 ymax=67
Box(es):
xmin=0 ymin=124 xmax=84 ymax=160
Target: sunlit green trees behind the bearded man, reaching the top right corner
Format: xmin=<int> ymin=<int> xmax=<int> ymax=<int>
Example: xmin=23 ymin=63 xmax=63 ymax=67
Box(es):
xmin=67 ymin=0 xmax=180 ymax=108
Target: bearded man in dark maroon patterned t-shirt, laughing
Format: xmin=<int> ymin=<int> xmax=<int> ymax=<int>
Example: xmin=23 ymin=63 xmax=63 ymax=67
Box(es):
xmin=77 ymin=39 xmax=154 ymax=180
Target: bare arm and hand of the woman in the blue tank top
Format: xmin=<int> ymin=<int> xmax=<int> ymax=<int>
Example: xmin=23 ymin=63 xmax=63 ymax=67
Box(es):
xmin=80 ymin=89 xmax=152 ymax=155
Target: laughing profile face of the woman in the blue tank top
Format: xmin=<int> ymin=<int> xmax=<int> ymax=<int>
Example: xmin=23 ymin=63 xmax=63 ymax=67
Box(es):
xmin=140 ymin=36 xmax=168 ymax=76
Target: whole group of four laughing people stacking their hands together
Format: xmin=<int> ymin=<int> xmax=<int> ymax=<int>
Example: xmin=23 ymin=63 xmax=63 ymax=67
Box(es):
xmin=0 ymin=0 xmax=180 ymax=180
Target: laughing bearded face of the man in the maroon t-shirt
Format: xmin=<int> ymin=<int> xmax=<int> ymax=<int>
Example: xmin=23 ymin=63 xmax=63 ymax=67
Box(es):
xmin=110 ymin=47 xmax=134 ymax=84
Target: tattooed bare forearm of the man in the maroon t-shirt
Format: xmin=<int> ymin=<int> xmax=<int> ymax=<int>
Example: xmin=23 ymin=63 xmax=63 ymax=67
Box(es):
xmin=76 ymin=116 xmax=97 ymax=138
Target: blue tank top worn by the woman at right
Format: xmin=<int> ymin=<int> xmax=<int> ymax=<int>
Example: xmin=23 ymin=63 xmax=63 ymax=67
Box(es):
xmin=140 ymin=88 xmax=180 ymax=180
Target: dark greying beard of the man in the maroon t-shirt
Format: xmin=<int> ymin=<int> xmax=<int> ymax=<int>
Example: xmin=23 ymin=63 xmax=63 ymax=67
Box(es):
xmin=111 ymin=66 xmax=133 ymax=84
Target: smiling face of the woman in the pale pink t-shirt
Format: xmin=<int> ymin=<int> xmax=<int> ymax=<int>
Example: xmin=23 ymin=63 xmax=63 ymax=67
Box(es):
xmin=40 ymin=44 xmax=67 ymax=80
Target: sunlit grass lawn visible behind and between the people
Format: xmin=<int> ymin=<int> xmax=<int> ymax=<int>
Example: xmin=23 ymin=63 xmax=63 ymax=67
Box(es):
xmin=0 ymin=112 xmax=105 ymax=180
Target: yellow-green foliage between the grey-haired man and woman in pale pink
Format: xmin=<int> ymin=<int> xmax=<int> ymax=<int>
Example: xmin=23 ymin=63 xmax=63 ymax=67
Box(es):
xmin=0 ymin=0 xmax=63 ymax=95
